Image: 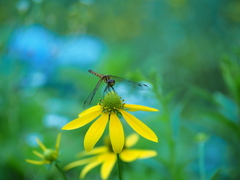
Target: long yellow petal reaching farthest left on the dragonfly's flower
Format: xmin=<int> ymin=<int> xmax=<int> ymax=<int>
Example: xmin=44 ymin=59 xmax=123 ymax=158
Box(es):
xmin=62 ymin=110 xmax=102 ymax=130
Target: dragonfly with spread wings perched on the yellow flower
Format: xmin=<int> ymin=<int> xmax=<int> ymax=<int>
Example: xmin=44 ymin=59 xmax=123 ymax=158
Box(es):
xmin=83 ymin=70 xmax=149 ymax=107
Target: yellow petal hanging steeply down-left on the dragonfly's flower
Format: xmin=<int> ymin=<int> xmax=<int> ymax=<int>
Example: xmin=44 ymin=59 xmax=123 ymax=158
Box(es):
xmin=84 ymin=113 xmax=109 ymax=152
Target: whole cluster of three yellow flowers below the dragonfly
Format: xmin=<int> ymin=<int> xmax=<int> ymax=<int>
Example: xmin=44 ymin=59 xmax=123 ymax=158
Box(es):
xmin=26 ymin=91 xmax=158 ymax=179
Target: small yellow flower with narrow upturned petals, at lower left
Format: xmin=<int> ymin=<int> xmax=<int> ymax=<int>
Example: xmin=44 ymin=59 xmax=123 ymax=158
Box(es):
xmin=26 ymin=133 xmax=61 ymax=165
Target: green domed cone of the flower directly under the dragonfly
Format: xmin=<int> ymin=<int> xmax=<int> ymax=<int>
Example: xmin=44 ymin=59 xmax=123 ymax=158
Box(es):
xmin=101 ymin=91 xmax=124 ymax=114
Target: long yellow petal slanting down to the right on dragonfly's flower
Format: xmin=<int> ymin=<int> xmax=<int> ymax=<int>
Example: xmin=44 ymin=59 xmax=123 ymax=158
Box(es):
xmin=120 ymin=110 xmax=158 ymax=142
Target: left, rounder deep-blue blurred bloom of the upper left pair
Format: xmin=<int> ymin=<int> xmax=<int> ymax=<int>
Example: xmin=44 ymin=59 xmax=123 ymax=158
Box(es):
xmin=9 ymin=25 xmax=57 ymax=68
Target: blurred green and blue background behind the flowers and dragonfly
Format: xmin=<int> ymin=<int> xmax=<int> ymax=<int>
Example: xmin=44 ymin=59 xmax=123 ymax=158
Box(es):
xmin=0 ymin=0 xmax=240 ymax=180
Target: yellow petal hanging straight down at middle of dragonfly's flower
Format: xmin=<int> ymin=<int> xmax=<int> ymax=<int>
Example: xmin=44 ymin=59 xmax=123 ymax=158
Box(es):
xmin=109 ymin=113 xmax=124 ymax=153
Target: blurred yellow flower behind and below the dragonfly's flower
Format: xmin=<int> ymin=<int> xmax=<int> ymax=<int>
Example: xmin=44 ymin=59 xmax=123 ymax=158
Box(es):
xmin=64 ymin=133 xmax=157 ymax=179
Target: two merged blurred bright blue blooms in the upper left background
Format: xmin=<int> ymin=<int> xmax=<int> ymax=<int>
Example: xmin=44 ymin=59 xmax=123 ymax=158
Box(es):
xmin=9 ymin=25 xmax=105 ymax=72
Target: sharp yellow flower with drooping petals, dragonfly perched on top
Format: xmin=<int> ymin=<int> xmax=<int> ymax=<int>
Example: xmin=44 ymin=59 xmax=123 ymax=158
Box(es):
xmin=62 ymin=91 xmax=158 ymax=153
